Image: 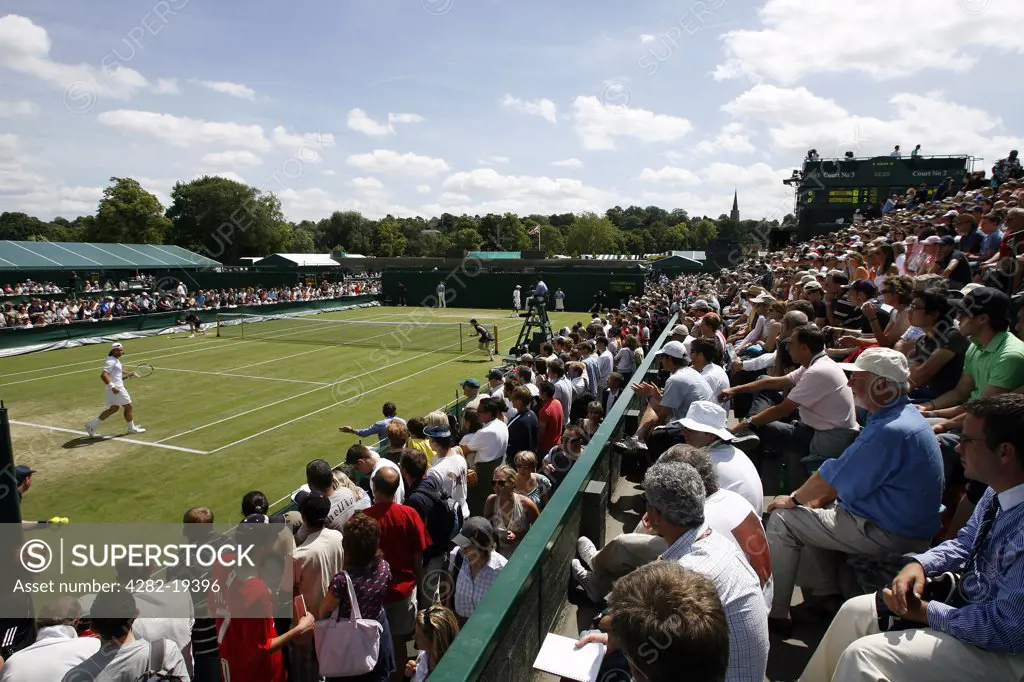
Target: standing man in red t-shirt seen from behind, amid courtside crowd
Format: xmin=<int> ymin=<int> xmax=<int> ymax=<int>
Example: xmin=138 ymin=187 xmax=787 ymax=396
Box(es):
xmin=365 ymin=468 xmax=430 ymax=679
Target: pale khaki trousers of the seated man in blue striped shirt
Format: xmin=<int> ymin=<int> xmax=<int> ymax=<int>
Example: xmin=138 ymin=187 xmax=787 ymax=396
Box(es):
xmin=800 ymin=594 xmax=1024 ymax=682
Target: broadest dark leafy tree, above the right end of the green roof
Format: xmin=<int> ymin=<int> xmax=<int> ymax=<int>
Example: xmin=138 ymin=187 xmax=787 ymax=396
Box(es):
xmin=167 ymin=176 xmax=289 ymax=263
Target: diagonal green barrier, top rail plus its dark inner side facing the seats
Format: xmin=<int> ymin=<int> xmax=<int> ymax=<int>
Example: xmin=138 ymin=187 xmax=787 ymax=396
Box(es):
xmin=430 ymin=316 xmax=676 ymax=682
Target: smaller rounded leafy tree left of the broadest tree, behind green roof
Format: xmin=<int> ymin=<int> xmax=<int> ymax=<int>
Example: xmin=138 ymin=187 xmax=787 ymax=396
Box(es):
xmin=93 ymin=177 xmax=171 ymax=244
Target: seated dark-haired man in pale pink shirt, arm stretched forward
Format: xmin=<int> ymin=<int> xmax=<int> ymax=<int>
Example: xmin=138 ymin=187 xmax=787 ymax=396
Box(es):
xmin=720 ymin=325 xmax=858 ymax=491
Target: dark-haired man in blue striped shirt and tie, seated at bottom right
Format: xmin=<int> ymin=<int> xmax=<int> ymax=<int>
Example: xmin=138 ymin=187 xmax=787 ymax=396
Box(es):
xmin=801 ymin=393 xmax=1024 ymax=682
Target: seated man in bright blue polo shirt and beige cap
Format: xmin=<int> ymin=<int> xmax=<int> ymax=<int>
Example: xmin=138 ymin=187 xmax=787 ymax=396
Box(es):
xmin=767 ymin=347 xmax=944 ymax=635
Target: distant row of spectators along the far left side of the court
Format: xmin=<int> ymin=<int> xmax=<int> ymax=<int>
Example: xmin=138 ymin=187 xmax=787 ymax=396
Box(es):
xmin=0 ymin=279 xmax=380 ymax=329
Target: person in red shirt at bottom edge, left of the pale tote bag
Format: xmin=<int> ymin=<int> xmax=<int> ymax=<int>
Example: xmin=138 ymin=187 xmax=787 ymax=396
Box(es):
xmin=217 ymin=514 xmax=314 ymax=682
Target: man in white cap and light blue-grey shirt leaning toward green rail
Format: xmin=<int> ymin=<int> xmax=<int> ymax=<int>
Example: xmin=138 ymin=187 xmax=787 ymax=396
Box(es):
xmin=620 ymin=341 xmax=714 ymax=456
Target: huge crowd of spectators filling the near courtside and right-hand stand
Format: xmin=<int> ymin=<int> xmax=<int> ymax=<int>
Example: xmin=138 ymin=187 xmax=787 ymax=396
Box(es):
xmin=9 ymin=157 xmax=1024 ymax=682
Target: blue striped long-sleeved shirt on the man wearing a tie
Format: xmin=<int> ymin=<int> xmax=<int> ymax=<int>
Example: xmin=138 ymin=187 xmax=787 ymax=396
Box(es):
xmin=914 ymin=485 xmax=1024 ymax=654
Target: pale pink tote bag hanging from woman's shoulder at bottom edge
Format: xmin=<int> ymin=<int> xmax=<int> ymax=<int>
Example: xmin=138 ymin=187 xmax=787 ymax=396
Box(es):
xmin=313 ymin=570 xmax=384 ymax=677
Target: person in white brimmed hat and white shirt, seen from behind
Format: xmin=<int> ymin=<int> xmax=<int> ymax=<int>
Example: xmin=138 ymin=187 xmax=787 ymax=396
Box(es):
xmin=679 ymin=400 xmax=764 ymax=511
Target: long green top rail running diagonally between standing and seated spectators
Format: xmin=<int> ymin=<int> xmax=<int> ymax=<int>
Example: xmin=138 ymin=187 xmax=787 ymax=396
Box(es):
xmin=430 ymin=315 xmax=678 ymax=682
